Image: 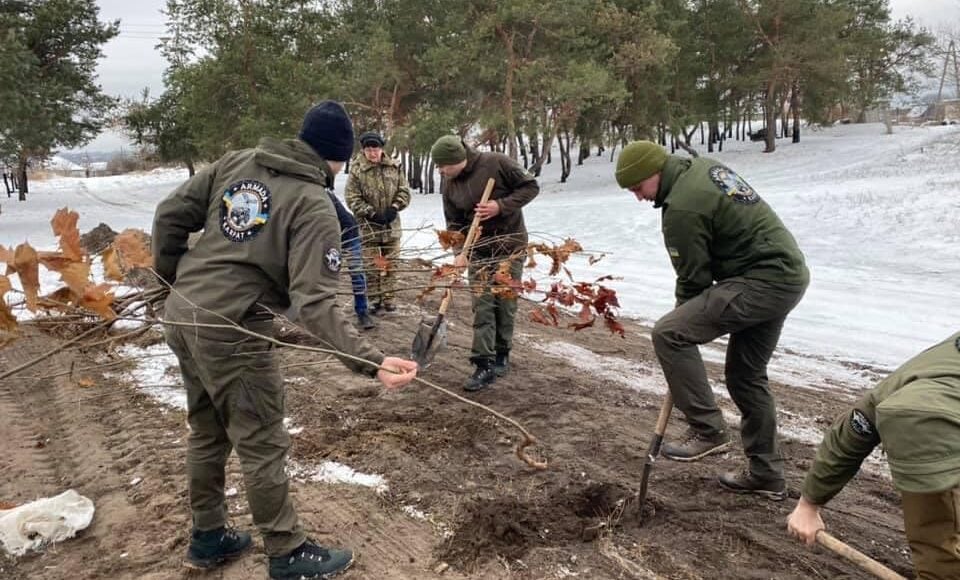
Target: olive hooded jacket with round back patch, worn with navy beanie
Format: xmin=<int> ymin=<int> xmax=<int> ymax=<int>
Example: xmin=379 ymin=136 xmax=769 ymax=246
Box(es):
xmin=152 ymin=138 xmax=383 ymax=374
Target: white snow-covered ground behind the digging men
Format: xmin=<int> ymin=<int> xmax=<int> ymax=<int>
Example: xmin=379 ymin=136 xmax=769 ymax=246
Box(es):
xmin=0 ymin=125 xmax=960 ymax=387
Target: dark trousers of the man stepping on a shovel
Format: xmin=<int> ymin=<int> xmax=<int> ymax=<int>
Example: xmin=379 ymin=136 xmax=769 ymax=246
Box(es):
xmin=651 ymin=278 xmax=806 ymax=480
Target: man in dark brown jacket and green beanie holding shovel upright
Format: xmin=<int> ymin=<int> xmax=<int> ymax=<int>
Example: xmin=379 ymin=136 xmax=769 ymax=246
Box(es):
xmin=430 ymin=135 xmax=540 ymax=391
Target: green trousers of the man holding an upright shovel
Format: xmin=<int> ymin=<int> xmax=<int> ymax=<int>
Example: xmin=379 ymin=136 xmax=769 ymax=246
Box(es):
xmin=469 ymin=256 xmax=524 ymax=364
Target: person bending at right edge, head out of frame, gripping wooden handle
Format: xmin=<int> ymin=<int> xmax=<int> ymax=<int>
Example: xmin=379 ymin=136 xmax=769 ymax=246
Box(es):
xmin=787 ymin=333 xmax=960 ymax=580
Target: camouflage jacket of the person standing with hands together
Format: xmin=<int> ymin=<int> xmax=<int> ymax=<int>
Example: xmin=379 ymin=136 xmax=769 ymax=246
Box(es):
xmin=345 ymin=153 xmax=410 ymax=241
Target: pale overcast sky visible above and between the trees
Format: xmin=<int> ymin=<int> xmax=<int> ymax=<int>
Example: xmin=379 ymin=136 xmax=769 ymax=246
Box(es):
xmin=73 ymin=0 xmax=960 ymax=150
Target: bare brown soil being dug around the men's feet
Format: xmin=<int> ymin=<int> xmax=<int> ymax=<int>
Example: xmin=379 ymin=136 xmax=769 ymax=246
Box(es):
xmin=0 ymin=272 xmax=910 ymax=580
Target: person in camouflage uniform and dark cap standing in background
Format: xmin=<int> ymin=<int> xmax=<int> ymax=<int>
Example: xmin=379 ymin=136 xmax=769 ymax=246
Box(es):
xmin=346 ymin=131 xmax=410 ymax=313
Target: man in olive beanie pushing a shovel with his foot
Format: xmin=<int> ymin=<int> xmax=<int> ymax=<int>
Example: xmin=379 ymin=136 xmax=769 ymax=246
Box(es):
xmin=616 ymin=141 xmax=809 ymax=500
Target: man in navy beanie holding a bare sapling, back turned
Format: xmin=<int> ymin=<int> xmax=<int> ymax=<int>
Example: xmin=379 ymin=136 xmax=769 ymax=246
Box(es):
xmin=153 ymin=101 xmax=416 ymax=579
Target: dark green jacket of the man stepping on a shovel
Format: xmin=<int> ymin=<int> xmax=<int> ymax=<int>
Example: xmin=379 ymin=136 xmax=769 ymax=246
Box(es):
xmin=654 ymin=155 xmax=810 ymax=304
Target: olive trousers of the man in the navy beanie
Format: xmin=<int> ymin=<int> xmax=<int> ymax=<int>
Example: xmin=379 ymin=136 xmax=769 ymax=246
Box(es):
xmin=165 ymin=322 xmax=306 ymax=556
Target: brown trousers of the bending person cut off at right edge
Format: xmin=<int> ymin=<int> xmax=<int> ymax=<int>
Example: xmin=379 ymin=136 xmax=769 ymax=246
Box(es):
xmin=901 ymin=488 xmax=960 ymax=580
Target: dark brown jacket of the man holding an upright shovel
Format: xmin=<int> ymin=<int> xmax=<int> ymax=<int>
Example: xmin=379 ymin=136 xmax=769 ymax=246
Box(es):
xmin=440 ymin=148 xmax=540 ymax=258
